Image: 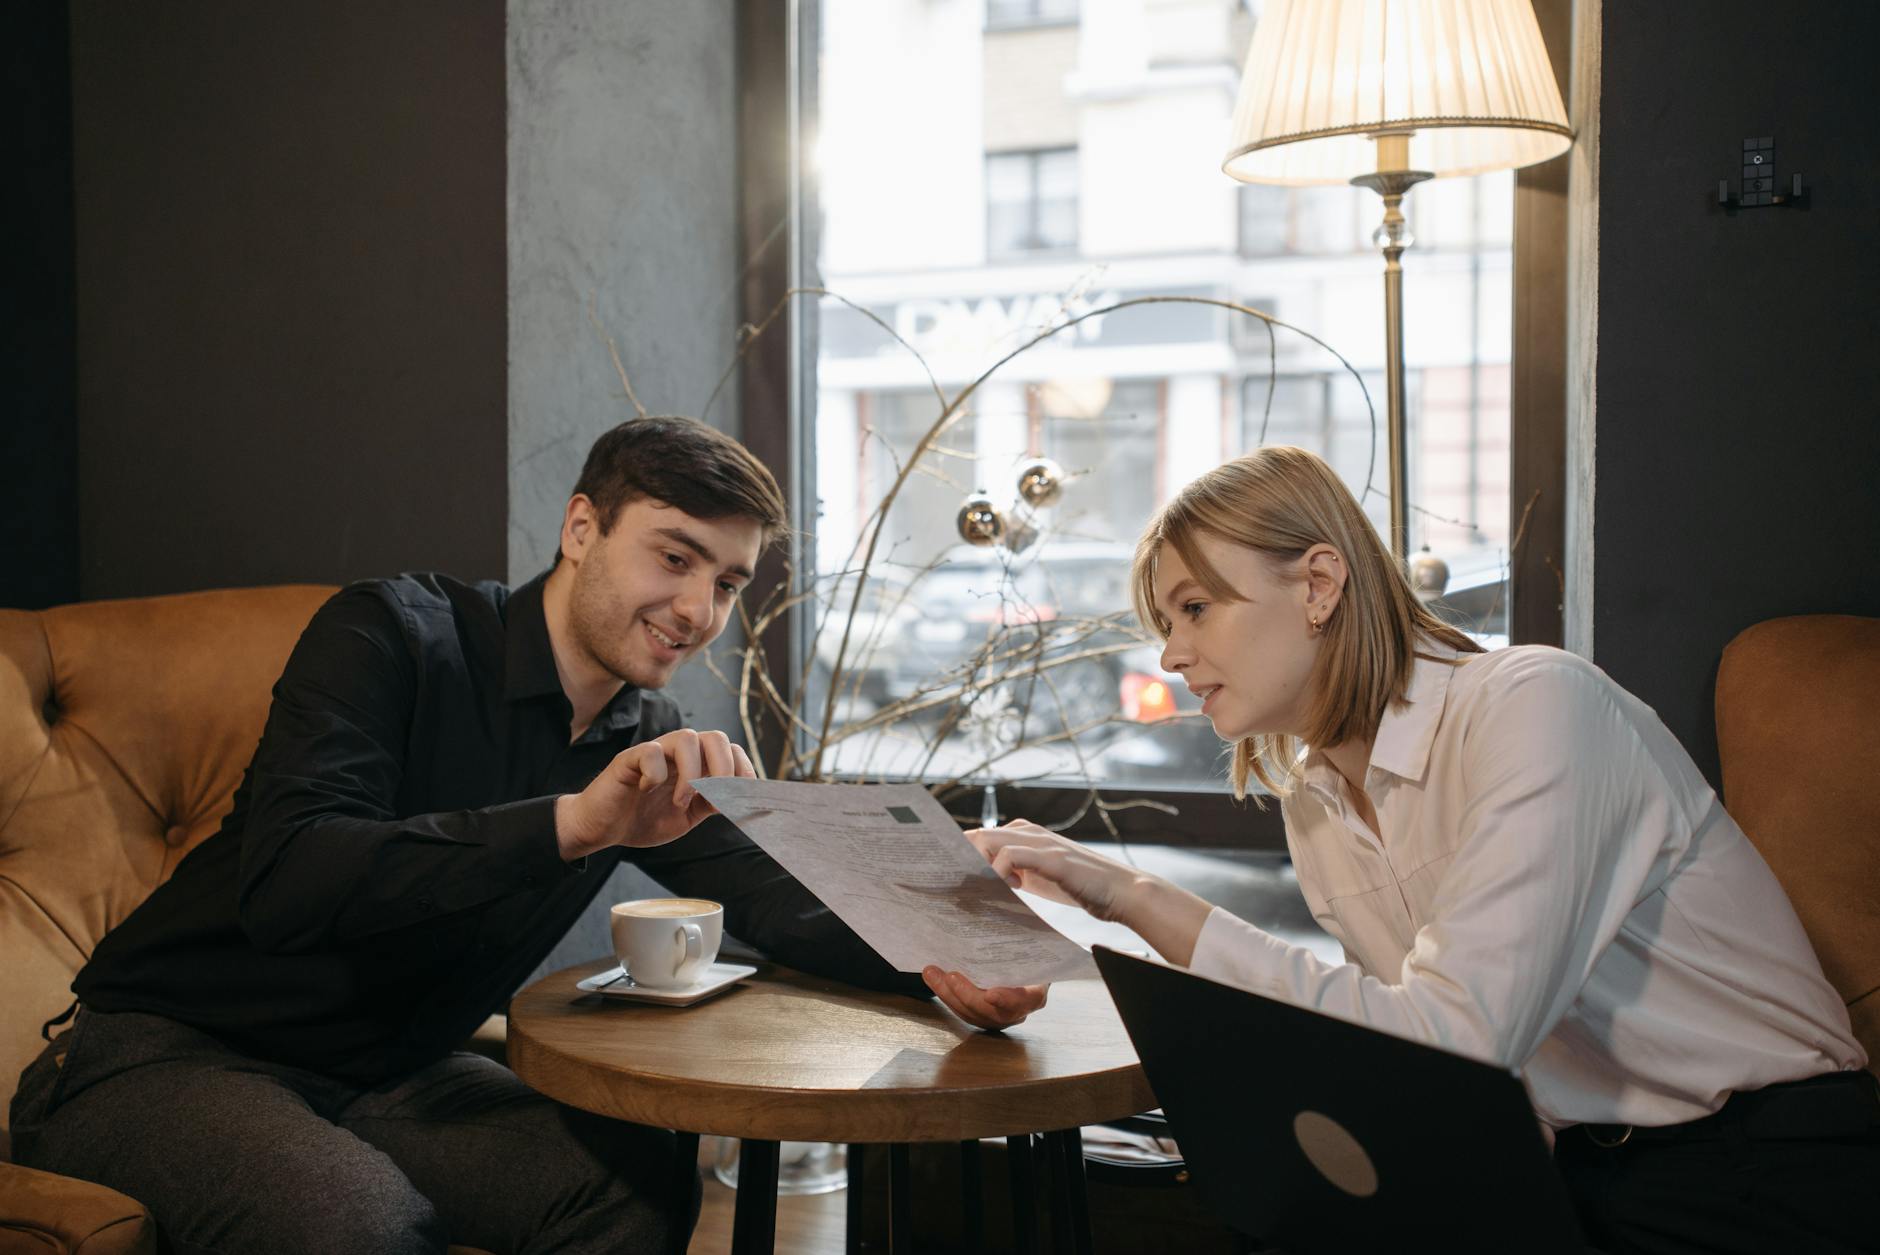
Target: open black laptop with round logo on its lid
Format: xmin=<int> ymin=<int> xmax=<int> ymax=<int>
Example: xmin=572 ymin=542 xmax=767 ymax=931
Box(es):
xmin=1094 ymin=947 xmax=1587 ymax=1255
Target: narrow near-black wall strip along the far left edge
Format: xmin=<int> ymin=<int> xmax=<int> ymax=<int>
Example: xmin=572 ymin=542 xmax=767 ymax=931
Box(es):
xmin=0 ymin=0 xmax=79 ymax=611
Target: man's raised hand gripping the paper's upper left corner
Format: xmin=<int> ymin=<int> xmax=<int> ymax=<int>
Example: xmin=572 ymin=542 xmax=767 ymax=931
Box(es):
xmin=555 ymin=727 xmax=758 ymax=862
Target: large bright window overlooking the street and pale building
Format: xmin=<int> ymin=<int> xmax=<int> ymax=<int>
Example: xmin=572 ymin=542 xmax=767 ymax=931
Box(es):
xmin=803 ymin=0 xmax=1513 ymax=804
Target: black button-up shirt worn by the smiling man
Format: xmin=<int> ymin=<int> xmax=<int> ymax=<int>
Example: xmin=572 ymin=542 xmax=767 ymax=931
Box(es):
xmin=73 ymin=575 xmax=925 ymax=1082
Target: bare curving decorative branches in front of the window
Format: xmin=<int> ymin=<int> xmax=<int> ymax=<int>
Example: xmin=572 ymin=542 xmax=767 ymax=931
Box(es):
xmin=588 ymin=274 xmax=1391 ymax=836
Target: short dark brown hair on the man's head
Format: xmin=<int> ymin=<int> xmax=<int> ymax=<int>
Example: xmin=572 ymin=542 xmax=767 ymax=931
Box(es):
xmin=556 ymin=415 xmax=790 ymax=556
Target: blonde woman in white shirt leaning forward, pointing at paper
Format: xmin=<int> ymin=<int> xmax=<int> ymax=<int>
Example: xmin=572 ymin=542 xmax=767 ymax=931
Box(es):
xmin=925 ymin=447 xmax=1880 ymax=1251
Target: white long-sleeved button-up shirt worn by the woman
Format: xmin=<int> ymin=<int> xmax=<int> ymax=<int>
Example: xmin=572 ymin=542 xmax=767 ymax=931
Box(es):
xmin=1190 ymin=644 xmax=1867 ymax=1127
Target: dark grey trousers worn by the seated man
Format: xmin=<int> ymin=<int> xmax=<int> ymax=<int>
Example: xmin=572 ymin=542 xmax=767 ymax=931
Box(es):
xmin=11 ymin=1009 xmax=699 ymax=1255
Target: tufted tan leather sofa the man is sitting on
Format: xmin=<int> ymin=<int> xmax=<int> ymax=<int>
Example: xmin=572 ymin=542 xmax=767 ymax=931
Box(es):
xmin=0 ymin=586 xmax=496 ymax=1255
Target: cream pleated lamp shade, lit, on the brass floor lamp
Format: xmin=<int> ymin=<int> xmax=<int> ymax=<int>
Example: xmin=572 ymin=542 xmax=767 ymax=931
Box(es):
xmin=1222 ymin=0 xmax=1574 ymax=184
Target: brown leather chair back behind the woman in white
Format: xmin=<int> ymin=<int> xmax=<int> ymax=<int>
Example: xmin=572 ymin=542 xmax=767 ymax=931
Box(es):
xmin=1716 ymin=614 xmax=1880 ymax=1071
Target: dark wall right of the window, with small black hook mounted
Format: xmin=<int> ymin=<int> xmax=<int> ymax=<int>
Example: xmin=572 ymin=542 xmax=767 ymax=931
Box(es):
xmin=1592 ymin=0 xmax=1880 ymax=782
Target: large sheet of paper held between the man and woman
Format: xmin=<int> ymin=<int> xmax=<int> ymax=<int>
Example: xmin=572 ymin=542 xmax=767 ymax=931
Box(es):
xmin=692 ymin=776 xmax=1096 ymax=988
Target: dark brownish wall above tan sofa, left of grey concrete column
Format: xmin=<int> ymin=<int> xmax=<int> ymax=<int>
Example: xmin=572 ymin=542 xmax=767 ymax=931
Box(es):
xmin=71 ymin=0 xmax=508 ymax=597
